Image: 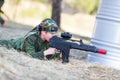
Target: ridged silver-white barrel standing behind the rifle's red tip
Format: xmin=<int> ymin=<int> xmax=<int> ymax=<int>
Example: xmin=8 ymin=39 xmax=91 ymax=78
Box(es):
xmin=87 ymin=0 xmax=120 ymax=69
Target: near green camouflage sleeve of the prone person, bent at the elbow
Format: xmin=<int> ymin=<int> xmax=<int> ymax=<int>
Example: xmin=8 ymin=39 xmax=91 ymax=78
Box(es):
xmin=24 ymin=37 xmax=44 ymax=59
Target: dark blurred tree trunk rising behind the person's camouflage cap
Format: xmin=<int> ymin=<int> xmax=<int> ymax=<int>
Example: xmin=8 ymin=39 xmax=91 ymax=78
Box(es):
xmin=52 ymin=0 xmax=62 ymax=28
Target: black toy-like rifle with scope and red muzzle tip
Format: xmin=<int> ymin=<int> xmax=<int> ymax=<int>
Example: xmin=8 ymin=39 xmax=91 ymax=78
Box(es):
xmin=49 ymin=32 xmax=106 ymax=63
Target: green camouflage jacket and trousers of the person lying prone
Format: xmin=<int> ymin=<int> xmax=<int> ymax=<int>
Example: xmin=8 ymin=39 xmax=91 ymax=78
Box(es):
xmin=0 ymin=30 xmax=60 ymax=59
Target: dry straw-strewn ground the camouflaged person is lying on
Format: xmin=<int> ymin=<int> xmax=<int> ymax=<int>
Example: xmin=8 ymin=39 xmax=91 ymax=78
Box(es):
xmin=0 ymin=22 xmax=120 ymax=80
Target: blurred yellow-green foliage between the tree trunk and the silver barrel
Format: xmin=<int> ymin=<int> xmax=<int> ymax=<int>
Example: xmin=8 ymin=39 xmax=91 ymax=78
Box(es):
xmin=67 ymin=0 xmax=99 ymax=14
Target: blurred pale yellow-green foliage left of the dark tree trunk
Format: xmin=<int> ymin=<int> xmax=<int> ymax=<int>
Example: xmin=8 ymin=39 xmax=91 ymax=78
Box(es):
xmin=7 ymin=0 xmax=51 ymax=19
